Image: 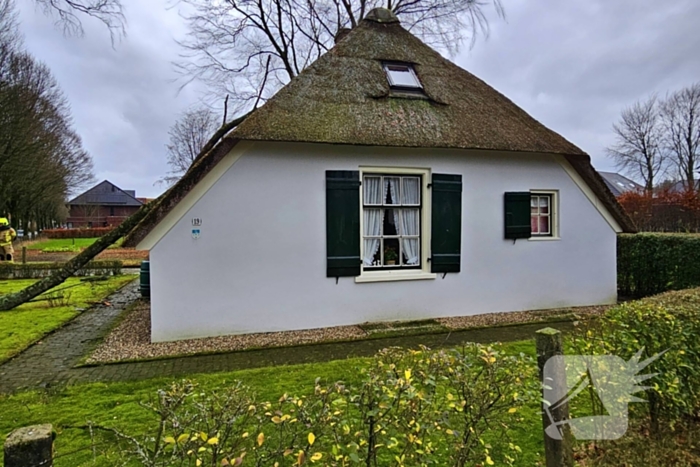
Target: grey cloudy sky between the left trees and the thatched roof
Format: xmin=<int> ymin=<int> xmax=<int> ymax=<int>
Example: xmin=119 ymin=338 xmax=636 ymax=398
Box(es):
xmin=21 ymin=0 xmax=204 ymax=196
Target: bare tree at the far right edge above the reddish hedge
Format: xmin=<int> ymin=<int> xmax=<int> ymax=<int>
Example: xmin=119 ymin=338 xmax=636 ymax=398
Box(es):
xmin=661 ymin=83 xmax=700 ymax=190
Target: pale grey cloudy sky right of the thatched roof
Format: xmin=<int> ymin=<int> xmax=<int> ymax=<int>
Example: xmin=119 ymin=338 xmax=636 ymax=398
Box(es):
xmin=457 ymin=0 xmax=700 ymax=177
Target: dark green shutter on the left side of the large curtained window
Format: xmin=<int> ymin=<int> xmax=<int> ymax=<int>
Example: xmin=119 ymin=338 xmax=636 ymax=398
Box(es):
xmin=326 ymin=170 xmax=361 ymax=277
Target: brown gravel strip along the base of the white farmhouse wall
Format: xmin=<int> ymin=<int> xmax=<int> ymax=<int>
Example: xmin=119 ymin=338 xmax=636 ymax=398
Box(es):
xmin=86 ymin=301 xmax=609 ymax=364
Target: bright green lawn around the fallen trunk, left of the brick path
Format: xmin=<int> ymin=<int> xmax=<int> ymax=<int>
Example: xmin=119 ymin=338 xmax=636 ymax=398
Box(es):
xmin=0 ymin=276 xmax=134 ymax=363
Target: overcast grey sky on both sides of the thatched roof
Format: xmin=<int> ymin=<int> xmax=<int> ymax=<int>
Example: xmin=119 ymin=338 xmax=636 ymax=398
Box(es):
xmin=17 ymin=0 xmax=700 ymax=197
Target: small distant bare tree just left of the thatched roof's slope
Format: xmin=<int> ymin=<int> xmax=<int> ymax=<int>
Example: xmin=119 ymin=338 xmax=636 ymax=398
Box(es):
xmin=158 ymin=108 xmax=220 ymax=186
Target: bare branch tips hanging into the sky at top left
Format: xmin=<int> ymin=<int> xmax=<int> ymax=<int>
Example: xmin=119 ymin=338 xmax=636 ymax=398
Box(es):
xmin=34 ymin=0 xmax=126 ymax=39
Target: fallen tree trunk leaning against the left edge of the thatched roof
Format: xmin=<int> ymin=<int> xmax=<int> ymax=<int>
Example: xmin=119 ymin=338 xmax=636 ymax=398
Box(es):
xmin=0 ymin=112 xmax=252 ymax=311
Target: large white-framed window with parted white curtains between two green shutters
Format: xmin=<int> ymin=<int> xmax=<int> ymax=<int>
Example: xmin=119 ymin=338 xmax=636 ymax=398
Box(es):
xmin=362 ymin=172 xmax=423 ymax=271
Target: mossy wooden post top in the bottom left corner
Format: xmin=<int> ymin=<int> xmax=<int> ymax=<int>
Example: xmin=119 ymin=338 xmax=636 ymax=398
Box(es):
xmin=5 ymin=425 xmax=54 ymax=467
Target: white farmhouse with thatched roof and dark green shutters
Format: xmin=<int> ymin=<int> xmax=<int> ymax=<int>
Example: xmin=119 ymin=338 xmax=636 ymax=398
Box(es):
xmin=125 ymin=9 xmax=634 ymax=341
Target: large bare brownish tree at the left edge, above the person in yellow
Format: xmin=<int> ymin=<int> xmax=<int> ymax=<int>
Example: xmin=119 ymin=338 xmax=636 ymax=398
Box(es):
xmin=0 ymin=0 xmax=92 ymax=229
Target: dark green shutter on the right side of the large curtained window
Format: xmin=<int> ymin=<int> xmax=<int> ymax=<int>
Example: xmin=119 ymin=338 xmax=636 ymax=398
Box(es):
xmin=430 ymin=174 xmax=462 ymax=272
